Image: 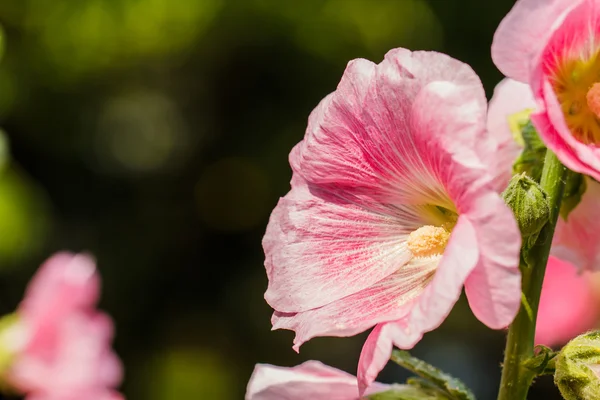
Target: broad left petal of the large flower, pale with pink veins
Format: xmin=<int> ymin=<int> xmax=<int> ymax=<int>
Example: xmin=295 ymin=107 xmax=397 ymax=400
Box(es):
xmin=263 ymin=177 xmax=420 ymax=313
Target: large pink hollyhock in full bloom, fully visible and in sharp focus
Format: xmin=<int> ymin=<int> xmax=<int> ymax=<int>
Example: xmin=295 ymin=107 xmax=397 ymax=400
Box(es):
xmin=263 ymin=49 xmax=521 ymax=390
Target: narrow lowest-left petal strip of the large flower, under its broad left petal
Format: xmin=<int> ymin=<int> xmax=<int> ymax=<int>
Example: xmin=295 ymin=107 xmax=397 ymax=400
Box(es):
xmin=271 ymin=257 xmax=441 ymax=351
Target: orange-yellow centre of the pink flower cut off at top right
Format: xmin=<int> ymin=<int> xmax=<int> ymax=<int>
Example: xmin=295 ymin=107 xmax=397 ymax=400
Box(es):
xmin=552 ymin=54 xmax=600 ymax=145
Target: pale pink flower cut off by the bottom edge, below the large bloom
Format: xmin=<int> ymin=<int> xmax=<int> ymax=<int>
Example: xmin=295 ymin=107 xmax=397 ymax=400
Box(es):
xmin=246 ymin=361 xmax=392 ymax=400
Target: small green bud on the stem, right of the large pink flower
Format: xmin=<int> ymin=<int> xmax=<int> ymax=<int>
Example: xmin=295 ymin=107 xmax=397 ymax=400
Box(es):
xmin=502 ymin=173 xmax=550 ymax=239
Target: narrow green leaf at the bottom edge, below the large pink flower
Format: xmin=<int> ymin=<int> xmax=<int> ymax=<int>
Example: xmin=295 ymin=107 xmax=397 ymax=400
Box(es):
xmin=392 ymin=350 xmax=475 ymax=400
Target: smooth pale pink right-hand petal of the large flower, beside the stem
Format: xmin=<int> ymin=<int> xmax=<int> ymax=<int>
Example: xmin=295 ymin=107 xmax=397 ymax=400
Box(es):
xmin=465 ymin=192 xmax=521 ymax=329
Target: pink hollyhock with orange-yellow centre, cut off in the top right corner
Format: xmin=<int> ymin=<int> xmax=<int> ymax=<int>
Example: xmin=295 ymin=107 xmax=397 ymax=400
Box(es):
xmin=492 ymin=0 xmax=600 ymax=180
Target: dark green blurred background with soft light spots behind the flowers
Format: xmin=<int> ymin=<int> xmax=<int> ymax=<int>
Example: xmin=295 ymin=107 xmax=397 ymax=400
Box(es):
xmin=0 ymin=0 xmax=576 ymax=400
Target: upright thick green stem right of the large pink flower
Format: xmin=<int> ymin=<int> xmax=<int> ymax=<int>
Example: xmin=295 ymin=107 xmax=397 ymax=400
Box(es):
xmin=498 ymin=150 xmax=566 ymax=400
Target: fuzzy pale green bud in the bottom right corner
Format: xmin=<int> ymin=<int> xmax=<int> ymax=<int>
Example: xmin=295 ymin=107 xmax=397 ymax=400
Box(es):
xmin=554 ymin=332 xmax=600 ymax=400
